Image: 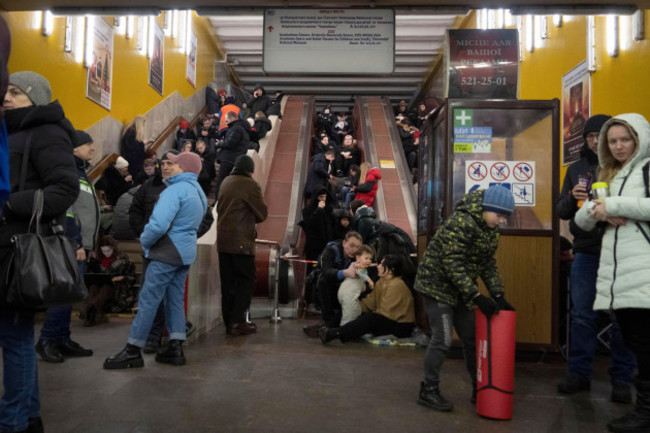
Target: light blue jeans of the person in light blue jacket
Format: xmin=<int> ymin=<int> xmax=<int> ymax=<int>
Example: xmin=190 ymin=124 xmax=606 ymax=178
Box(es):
xmin=127 ymin=260 xmax=190 ymax=348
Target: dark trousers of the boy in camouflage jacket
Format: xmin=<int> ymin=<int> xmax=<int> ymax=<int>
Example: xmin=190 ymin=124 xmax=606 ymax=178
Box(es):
xmin=424 ymin=296 xmax=476 ymax=386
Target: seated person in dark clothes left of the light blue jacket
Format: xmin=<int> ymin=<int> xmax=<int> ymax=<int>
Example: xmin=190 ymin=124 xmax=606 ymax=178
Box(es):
xmin=81 ymin=235 xmax=138 ymax=326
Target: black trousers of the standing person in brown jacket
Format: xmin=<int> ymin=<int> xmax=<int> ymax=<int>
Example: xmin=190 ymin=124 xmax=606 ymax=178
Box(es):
xmin=219 ymin=253 xmax=256 ymax=329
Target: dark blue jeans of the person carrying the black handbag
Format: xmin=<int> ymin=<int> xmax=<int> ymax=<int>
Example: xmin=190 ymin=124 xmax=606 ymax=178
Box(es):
xmin=0 ymin=310 xmax=41 ymax=433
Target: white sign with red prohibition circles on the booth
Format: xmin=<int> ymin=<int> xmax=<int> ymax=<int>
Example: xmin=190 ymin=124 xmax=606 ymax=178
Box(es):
xmin=465 ymin=161 xmax=535 ymax=206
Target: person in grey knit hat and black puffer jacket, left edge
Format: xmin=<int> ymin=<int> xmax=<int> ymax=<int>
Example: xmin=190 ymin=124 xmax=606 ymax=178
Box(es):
xmin=0 ymin=71 xmax=79 ymax=431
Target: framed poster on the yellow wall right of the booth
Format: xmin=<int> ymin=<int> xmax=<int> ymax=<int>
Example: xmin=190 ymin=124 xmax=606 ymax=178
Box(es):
xmin=562 ymin=60 xmax=591 ymax=165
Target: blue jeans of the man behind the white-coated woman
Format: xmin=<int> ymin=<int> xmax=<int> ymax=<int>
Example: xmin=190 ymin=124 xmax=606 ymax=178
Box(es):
xmin=568 ymin=253 xmax=636 ymax=384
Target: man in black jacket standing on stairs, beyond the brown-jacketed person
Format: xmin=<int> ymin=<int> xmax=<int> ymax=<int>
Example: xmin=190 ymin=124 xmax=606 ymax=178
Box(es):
xmin=214 ymin=111 xmax=251 ymax=200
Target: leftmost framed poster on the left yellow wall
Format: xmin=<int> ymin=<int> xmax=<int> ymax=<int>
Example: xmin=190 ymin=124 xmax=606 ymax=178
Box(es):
xmin=86 ymin=18 xmax=113 ymax=110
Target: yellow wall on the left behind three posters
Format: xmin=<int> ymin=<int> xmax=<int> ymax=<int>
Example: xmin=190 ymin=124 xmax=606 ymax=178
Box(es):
xmin=4 ymin=12 xmax=217 ymax=129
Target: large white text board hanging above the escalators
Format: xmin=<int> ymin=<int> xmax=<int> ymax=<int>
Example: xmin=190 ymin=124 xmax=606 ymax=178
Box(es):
xmin=264 ymin=9 xmax=395 ymax=75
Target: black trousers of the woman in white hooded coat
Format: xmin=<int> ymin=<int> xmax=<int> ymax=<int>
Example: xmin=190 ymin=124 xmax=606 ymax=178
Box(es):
xmin=616 ymin=308 xmax=650 ymax=381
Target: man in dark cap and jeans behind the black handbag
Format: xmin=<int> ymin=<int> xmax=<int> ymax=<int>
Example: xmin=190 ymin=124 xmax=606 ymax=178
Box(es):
xmin=36 ymin=131 xmax=99 ymax=363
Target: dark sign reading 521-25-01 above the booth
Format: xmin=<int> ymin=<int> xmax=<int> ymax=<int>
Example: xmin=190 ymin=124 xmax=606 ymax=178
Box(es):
xmin=445 ymin=29 xmax=519 ymax=99
